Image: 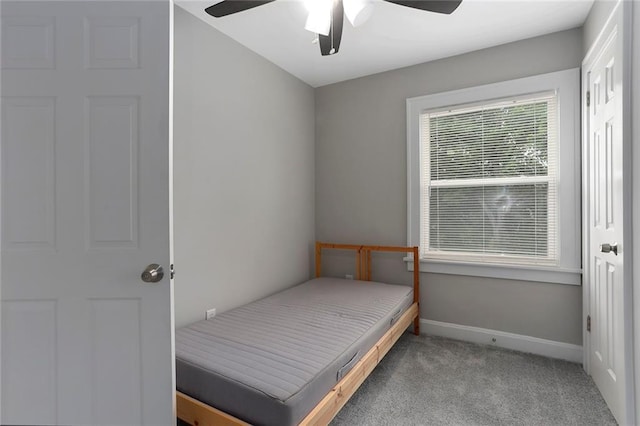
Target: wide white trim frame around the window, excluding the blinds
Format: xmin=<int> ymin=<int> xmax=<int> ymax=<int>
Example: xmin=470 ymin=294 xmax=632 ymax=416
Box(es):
xmin=406 ymin=68 xmax=582 ymax=285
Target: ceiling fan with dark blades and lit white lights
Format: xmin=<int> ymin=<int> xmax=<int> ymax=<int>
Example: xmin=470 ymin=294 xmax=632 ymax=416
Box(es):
xmin=205 ymin=0 xmax=462 ymax=56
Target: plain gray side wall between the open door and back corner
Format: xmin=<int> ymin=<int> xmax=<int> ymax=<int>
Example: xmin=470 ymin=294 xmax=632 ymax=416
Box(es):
xmin=174 ymin=8 xmax=314 ymax=327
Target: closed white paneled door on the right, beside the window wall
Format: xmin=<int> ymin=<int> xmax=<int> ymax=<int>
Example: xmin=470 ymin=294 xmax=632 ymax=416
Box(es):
xmin=583 ymin=2 xmax=631 ymax=424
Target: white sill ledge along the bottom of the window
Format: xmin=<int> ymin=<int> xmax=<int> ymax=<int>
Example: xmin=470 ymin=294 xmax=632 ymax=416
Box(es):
xmin=404 ymin=258 xmax=582 ymax=285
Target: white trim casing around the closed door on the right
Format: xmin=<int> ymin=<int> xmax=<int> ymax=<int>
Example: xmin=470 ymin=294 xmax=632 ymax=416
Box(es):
xmin=581 ymin=0 xmax=640 ymax=424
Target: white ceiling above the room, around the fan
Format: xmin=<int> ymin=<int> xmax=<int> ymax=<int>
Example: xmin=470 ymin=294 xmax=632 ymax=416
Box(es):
xmin=175 ymin=0 xmax=593 ymax=87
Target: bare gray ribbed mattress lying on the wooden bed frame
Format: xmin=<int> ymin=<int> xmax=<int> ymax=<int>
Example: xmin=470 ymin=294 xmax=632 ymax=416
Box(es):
xmin=176 ymin=278 xmax=413 ymax=426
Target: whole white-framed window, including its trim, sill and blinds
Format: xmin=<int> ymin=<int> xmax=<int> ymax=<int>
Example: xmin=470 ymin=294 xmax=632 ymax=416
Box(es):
xmin=407 ymin=70 xmax=580 ymax=284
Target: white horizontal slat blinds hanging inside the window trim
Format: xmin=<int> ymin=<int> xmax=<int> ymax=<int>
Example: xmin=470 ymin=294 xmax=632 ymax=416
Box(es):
xmin=420 ymin=92 xmax=558 ymax=265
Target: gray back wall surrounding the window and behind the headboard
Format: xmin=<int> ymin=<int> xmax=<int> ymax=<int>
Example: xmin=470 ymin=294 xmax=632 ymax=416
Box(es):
xmin=315 ymin=29 xmax=582 ymax=345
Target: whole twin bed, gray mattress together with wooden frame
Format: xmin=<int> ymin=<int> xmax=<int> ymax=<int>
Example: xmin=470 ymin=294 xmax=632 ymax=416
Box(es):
xmin=176 ymin=242 xmax=420 ymax=426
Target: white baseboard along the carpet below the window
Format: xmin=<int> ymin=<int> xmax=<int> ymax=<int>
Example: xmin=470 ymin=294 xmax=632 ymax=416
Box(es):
xmin=420 ymin=318 xmax=582 ymax=364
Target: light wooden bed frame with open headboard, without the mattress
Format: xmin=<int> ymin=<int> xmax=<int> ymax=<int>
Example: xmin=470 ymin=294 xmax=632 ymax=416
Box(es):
xmin=176 ymin=242 xmax=420 ymax=426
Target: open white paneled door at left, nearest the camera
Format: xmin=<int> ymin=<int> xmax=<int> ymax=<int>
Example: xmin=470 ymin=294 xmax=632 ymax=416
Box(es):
xmin=0 ymin=0 xmax=175 ymax=425
